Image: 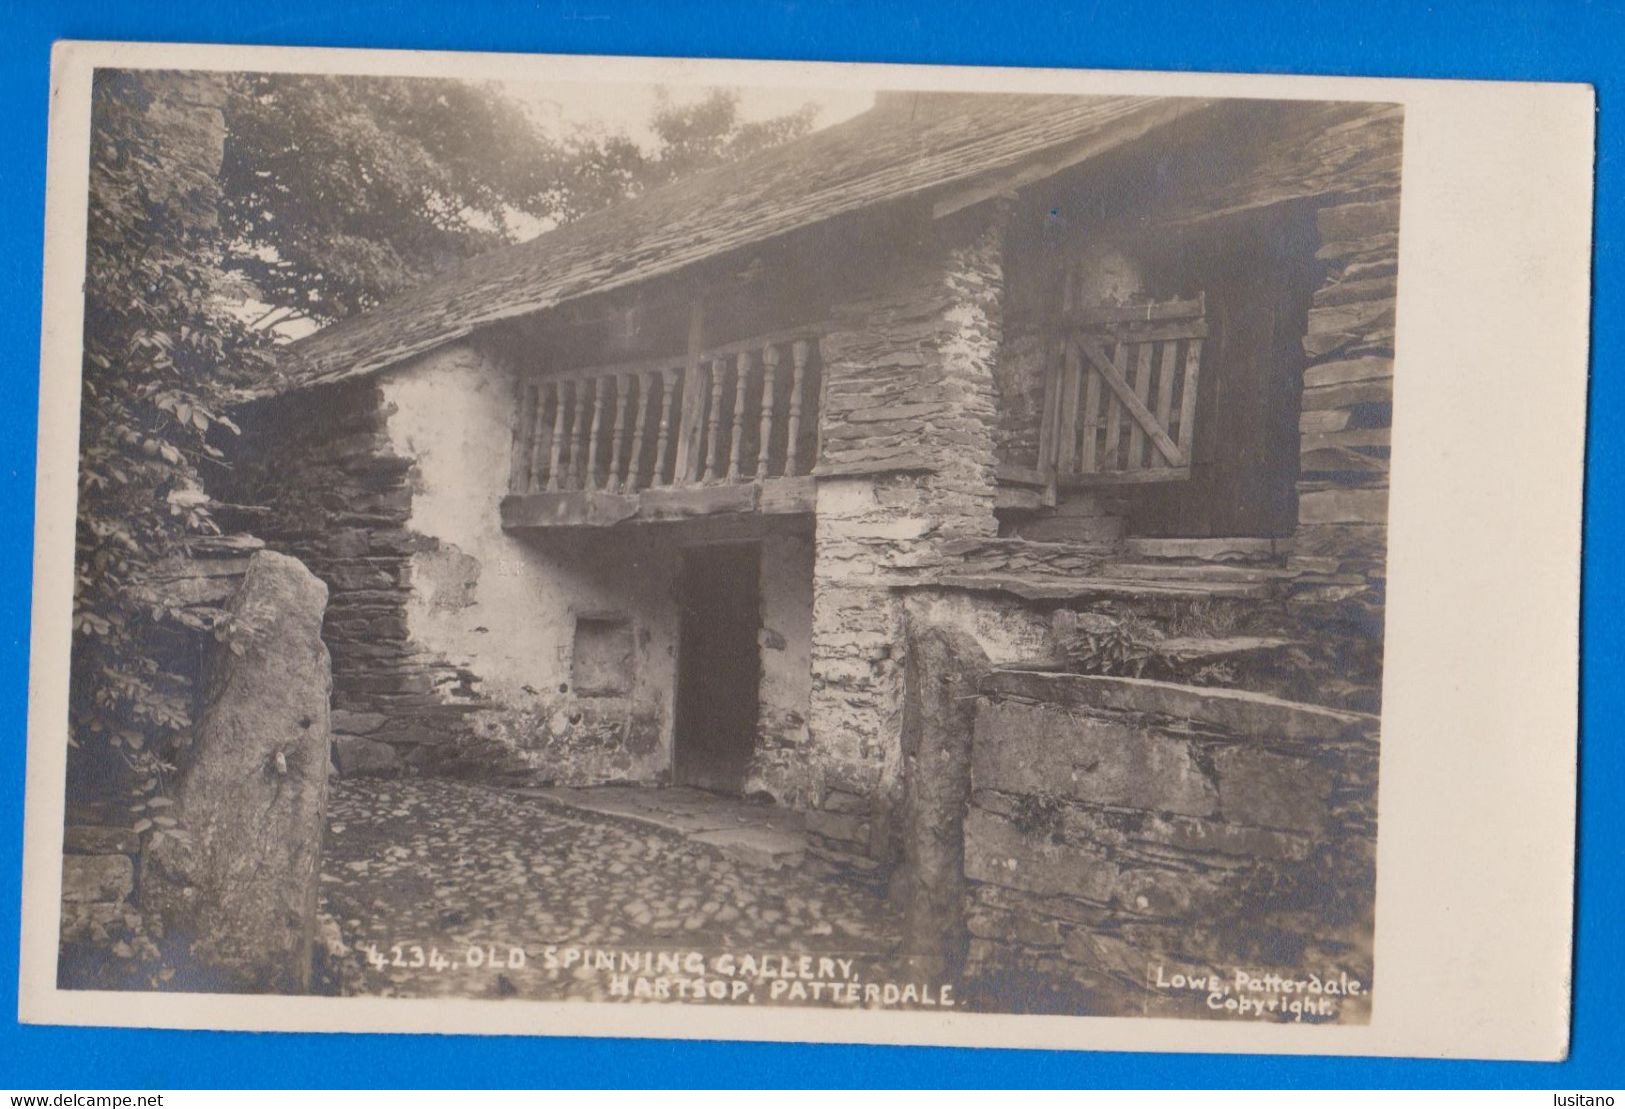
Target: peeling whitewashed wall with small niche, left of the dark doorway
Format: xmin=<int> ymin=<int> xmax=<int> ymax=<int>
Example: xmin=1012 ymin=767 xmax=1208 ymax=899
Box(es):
xmin=382 ymin=345 xmax=678 ymax=784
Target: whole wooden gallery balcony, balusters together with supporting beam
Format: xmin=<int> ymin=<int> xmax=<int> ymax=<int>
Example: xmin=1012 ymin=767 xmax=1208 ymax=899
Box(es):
xmin=502 ymin=330 xmax=822 ymax=530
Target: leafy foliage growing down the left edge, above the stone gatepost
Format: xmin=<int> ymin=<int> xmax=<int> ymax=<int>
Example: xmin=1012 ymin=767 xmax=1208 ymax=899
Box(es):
xmin=70 ymin=70 xmax=268 ymax=794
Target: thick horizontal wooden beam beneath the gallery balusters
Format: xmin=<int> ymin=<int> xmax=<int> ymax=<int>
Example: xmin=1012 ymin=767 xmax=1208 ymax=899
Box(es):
xmin=502 ymin=476 xmax=816 ymax=532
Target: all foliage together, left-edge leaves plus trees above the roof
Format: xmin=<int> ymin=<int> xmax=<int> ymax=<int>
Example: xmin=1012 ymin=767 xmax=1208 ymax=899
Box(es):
xmin=70 ymin=70 xmax=813 ymax=793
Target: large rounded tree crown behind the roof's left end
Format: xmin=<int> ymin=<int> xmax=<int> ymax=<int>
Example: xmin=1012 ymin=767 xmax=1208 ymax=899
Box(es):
xmin=221 ymin=73 xmax=559 ymax=322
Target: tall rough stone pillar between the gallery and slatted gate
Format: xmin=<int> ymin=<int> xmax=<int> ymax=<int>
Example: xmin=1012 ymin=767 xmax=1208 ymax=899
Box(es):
xmin=809 ymin=202 xmax=1008 ymax=860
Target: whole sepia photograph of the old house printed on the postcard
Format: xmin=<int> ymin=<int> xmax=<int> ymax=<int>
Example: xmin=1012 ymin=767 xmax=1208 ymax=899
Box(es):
xmin=15 ymin=36 xmax=1578 ymax=1050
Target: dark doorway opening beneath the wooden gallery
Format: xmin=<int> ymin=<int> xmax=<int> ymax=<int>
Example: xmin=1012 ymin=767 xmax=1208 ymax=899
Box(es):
xmin=671 ymin=543 xmax=762 ymax=794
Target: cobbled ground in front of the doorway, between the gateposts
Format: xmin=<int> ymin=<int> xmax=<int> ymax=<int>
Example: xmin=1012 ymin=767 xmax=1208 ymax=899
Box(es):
xmin=322 ymin=779 xmax=897 ymax=1000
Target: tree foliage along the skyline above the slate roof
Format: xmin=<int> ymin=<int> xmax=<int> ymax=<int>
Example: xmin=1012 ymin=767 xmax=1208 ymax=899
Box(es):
xmin=221 ymin=73 xmax=816 ymax=324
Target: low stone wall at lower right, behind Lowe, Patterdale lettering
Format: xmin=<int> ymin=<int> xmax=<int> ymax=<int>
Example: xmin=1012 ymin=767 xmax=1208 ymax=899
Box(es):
xmin=965 ymin=672 xmax=1376 ymax=1023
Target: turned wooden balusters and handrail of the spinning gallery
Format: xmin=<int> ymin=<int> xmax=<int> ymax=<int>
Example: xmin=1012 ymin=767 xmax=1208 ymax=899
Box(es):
xmin=509 ymin=332 xmax=821 ymax=494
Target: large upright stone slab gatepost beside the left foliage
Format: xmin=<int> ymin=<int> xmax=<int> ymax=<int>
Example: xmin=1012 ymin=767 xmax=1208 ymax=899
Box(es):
xmin=141 ymin=551 xmax=332 ymax=994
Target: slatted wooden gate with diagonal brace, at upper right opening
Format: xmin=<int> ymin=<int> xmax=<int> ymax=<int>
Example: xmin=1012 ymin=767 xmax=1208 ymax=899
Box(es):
xmin=1038 ymin=296 xmax=1207 ymax=488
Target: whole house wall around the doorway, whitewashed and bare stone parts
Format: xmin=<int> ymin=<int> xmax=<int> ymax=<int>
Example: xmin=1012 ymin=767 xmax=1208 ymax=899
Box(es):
xmin=226 ymin=343 xmax=825 ymax=800
